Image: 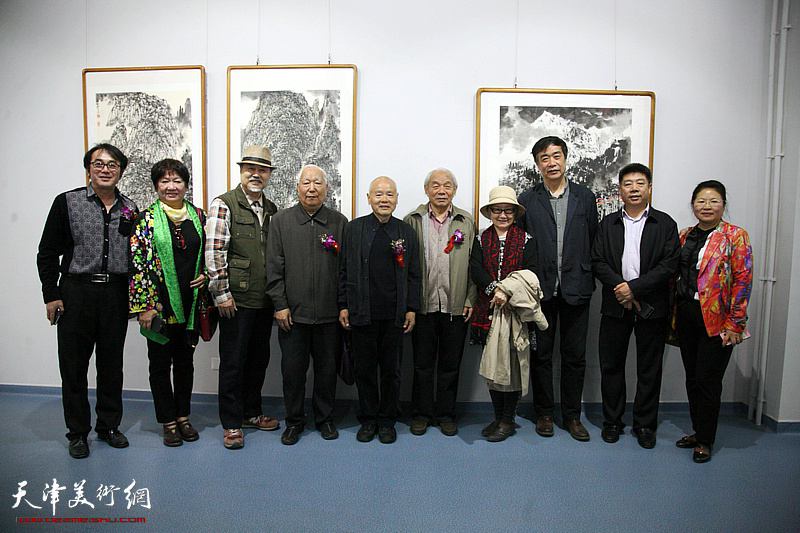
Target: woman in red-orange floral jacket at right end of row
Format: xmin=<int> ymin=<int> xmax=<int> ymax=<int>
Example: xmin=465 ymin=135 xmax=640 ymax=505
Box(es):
xmin=673 ymin=180 xmax=753 ymax=463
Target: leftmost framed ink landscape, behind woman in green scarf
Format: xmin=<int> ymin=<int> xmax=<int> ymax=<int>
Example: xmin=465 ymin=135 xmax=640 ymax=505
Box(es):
xmin=83 ymin=66 xmax=208 ymax=209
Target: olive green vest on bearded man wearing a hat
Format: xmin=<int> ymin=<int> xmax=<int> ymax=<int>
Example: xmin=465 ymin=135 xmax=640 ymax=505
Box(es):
xmin=219 ymin=187 xmax=277 ymax=309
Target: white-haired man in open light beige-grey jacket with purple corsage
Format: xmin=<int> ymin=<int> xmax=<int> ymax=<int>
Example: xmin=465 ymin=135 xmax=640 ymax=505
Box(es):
xmin=404 ymin=168 xmax=476 ymax=436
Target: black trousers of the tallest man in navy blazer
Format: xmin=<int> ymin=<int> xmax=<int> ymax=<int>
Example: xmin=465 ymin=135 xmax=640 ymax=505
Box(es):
xmin=531 ymin=293 xmax=589 ymax=424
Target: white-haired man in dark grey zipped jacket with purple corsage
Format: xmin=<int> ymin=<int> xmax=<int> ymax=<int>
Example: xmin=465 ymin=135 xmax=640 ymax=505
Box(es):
xmin=267 ymin=165 xmax=347 ymax=446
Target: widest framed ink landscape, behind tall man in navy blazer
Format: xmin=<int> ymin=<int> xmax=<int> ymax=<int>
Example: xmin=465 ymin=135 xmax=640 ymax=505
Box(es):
xmin=475 ymin=89 xmax=656 ymax=220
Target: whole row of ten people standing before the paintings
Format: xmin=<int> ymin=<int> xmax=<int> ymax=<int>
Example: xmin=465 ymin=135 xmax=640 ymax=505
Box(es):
xmin=37 ymin=137 xmax=752 ymax=462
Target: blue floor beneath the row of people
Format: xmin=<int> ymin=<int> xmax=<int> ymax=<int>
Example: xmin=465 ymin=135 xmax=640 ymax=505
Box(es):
xmin=0 ymin=391 xmax=800 ymax=532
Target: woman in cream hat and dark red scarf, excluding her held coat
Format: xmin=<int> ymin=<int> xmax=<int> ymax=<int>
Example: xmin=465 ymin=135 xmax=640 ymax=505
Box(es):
xmin=470 ymin=185 xmax=537 ymax=442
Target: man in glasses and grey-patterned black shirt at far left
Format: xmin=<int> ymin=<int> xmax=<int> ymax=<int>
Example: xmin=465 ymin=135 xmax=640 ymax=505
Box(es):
xmin=36 ymin=143 xmax=138 ymax=459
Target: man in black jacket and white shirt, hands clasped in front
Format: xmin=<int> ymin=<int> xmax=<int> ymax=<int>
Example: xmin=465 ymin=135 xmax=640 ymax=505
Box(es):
xmin=592 ymin=163 xmax=680 ymax=449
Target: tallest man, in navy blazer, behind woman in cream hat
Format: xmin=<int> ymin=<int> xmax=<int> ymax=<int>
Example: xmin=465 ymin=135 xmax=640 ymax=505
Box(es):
xmin=519 ymin=136 xmax=598 ymax=441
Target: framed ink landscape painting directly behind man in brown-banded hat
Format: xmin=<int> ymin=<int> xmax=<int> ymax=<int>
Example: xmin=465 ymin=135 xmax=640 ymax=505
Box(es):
xmin=228 ymin=65 xmax=358 ymax=219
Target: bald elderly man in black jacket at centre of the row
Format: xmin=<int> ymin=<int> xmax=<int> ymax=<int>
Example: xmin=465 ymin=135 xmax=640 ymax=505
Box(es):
xmin=339 ymin=176 xmax=420 ymax=444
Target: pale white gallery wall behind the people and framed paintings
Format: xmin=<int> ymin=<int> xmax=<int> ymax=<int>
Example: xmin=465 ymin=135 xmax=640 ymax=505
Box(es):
xmin=0 ymin=0 xmax=800 ymax=421
